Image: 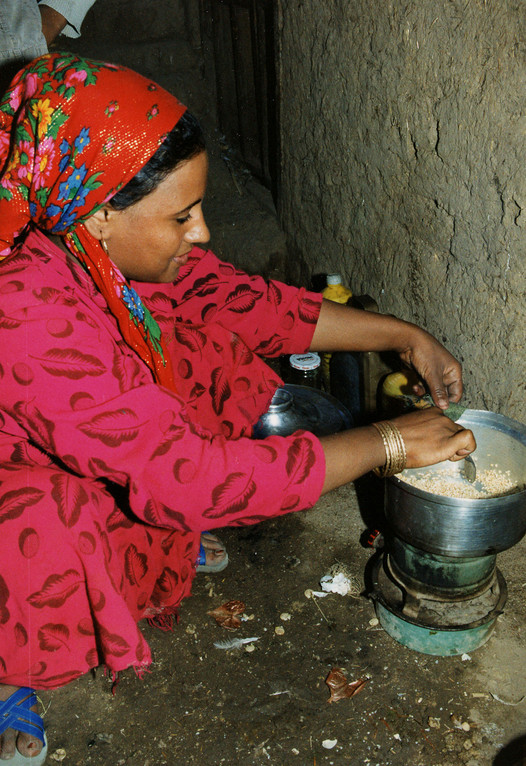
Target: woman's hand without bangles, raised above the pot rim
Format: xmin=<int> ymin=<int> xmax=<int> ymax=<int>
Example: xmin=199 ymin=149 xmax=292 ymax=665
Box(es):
xmin=399 ymin=327 xmax=463 ymax=410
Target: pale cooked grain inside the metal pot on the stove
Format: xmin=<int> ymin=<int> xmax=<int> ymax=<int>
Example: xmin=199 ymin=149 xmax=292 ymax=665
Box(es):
xmin=400 ymin=467 xmax=524 ymax=500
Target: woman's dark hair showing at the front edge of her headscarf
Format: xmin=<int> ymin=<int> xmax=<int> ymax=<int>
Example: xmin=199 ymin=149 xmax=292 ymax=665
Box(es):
xmin=109 ymin=112 xmax=205 ymax=210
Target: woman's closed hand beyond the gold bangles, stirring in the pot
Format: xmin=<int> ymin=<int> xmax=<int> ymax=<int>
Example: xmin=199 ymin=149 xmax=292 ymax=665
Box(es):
xmin=390 ymin=407 xmax=477 ymax=468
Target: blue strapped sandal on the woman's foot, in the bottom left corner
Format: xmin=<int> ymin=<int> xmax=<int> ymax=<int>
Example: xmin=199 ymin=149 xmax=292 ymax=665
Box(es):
xmin=0 ymin=686 xmax=47 ymax=766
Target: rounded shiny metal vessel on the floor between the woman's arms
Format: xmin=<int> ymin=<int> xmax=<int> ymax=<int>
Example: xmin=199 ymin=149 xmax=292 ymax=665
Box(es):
xmin=253 ymin=383 xmax=353 ymax=439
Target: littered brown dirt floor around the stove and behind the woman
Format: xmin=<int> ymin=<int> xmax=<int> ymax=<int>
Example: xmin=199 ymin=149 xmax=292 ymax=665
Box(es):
xmin=36 ymin=24 xmax=526 ymax=766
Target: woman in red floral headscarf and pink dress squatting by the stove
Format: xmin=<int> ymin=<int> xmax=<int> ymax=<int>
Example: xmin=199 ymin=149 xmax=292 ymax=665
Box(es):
xmin=0 ymin=54 xmax=475 ymax=763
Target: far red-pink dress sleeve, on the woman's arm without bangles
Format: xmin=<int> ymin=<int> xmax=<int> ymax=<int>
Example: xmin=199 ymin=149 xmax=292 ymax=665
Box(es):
xmin=136 ymin=247 xmax=322 ymax=356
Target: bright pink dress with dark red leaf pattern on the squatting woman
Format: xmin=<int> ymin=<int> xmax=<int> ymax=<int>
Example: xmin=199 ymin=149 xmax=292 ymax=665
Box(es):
xmin=0 ymin=231 xmax=325 ymax=689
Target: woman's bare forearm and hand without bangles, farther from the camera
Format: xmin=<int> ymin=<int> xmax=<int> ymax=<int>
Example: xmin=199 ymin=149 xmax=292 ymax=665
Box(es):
xmin=311 ymin=300 xmax=462 ymax=409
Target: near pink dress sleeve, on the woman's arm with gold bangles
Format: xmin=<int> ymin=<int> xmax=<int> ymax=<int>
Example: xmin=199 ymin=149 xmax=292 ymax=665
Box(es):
xmin=0 ymin=258 xmax=325 ymax=531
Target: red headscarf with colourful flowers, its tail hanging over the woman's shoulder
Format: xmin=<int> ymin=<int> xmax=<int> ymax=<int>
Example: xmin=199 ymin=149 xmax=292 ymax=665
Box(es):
xmin=0 ymin=53 xmax=190 ymax=390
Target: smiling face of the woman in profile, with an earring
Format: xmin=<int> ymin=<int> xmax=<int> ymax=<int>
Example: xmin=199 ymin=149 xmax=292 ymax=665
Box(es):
xmin=94 ymin=152 xmax=210 ymax=282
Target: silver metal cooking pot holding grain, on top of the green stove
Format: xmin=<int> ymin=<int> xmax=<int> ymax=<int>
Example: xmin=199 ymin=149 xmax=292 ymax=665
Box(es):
xmin=386 ymin=410 xmax=526 ymax=557
